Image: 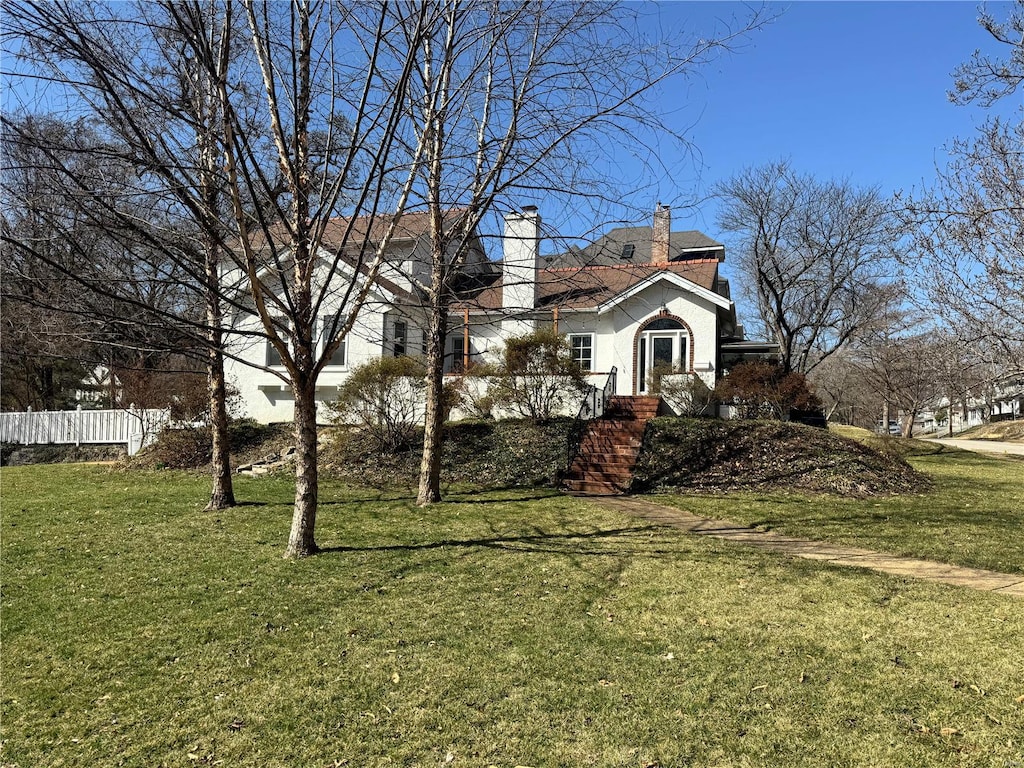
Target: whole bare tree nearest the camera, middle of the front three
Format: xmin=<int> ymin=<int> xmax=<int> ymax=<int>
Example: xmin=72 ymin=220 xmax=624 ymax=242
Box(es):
xmin=3 ymin=0 xmax=424 ymax=556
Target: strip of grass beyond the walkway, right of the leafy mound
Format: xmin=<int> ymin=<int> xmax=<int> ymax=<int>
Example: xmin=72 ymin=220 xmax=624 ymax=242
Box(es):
xmin=657 ymin=441 xmax=1024 ymax=573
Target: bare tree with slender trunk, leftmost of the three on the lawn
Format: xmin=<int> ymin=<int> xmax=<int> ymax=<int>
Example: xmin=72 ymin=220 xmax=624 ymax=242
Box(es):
xmin=5 ymin=2 xmax=243 ymax=509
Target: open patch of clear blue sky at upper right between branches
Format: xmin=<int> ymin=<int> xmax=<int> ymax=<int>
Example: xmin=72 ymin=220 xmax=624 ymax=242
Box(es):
xmin=638 ymin=2 xmax=1020 ymax=237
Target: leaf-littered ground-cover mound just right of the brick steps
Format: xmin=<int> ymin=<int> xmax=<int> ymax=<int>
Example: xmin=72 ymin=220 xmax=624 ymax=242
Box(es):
xmin=633 ymin=418 xmax=930 ymax=496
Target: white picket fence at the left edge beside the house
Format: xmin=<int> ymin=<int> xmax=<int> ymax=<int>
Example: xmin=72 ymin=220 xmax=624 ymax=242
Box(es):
xmin=0 ymin=406 xmax=171 ymax=455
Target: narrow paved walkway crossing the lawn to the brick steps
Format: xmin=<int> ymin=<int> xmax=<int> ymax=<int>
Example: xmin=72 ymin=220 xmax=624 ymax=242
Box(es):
xmin=587 ymin=496 xmax=1024 ymax=598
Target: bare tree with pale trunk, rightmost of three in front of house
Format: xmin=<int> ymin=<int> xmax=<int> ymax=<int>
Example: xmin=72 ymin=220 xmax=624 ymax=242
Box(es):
xmin=374 ymin=0 xmax=762 ymax=505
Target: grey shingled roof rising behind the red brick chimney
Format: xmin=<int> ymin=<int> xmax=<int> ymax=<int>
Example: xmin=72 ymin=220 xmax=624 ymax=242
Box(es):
xmin=548 ymin=226 xmax=725 ymax=268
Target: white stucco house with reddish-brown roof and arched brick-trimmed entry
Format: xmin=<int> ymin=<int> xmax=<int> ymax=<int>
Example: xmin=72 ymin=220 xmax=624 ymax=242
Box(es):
xmin=227 ymin=205 xmax=774 ymax=422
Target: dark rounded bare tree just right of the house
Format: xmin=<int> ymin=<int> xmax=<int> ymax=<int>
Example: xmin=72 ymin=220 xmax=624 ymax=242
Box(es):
xmin=716 ymin=162 xmax=899 ymax=374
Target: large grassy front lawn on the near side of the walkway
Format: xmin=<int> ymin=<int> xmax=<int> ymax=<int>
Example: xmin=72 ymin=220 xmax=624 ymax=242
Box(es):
xmin=0 ymin=466 xmax=1024 ymax=768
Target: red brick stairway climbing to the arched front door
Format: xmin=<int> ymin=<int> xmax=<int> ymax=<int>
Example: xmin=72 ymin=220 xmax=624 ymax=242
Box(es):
xmin=564 ymin=397 xmax=662 ymax=496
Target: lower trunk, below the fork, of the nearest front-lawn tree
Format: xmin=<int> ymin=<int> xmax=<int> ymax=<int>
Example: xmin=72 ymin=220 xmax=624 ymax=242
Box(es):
xmin=285 ymin=380 xmax=319 ymax=557
